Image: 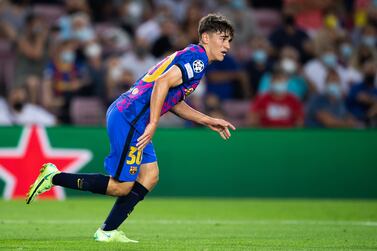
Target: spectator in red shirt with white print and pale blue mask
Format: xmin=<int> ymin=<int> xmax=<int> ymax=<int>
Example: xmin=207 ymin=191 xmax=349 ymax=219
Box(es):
xmin=248 ymin=69 xmax=304 ymax=128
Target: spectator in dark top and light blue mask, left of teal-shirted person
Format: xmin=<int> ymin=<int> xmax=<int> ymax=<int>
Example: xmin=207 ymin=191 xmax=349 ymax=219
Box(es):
xmin=244 ymin=37 xmax=273 ymax=97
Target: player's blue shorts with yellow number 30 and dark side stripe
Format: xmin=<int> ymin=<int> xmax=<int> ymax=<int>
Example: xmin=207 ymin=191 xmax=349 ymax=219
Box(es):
xmin=104 ymin=102 xmax=157 ymax=182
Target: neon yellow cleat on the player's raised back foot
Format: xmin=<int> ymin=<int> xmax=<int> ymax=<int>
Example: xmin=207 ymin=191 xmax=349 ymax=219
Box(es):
xmin=26 ymin=163 xmax=60 ymax=204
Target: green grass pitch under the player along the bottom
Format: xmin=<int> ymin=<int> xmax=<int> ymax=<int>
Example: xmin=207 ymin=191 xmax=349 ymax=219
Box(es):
xmin=0 ymin=198 xmax=377 ymax=250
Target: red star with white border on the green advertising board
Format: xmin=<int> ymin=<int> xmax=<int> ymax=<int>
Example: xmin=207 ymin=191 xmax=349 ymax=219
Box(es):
xmin=0 ymin=126 xmax=92 ymax=199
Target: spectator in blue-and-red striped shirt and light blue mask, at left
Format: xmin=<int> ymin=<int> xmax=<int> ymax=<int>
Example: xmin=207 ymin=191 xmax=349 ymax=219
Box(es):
xmin=43 ymin=41 xmax=88 ymax=124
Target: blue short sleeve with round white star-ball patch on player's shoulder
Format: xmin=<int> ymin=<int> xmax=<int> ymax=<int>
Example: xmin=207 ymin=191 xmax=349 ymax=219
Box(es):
xmin=175 ymin=50 xmax=208 ymax=82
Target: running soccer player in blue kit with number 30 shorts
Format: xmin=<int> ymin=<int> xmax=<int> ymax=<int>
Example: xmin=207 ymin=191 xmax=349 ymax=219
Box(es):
xmin=26 ymin=14 xmax=235 ymax=242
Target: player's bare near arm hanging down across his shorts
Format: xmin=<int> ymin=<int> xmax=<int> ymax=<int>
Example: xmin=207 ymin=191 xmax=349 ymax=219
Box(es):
xmin=136 ymin=65 xmax=182 ymax=150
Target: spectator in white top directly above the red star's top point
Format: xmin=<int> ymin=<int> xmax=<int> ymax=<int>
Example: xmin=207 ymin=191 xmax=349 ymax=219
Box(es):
xmin=9 ymin=87 xmax=56 ymax=126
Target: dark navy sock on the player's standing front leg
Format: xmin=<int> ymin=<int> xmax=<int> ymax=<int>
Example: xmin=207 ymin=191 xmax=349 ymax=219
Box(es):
xmin=101 ymin=181 xmax=148 ymax=231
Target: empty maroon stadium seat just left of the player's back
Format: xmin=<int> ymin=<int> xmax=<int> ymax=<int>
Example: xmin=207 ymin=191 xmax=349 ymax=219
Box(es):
xmin=70 ymin=97 xmax=105 ymax=125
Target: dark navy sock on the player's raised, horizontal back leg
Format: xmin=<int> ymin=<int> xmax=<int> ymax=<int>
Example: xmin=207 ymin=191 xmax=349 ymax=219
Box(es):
xmin=52 ymin=173 xmax=110 ymax=194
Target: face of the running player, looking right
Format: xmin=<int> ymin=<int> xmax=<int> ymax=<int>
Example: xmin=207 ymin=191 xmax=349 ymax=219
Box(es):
xmin=208 ymin=32 xmax=232 ymax=61
